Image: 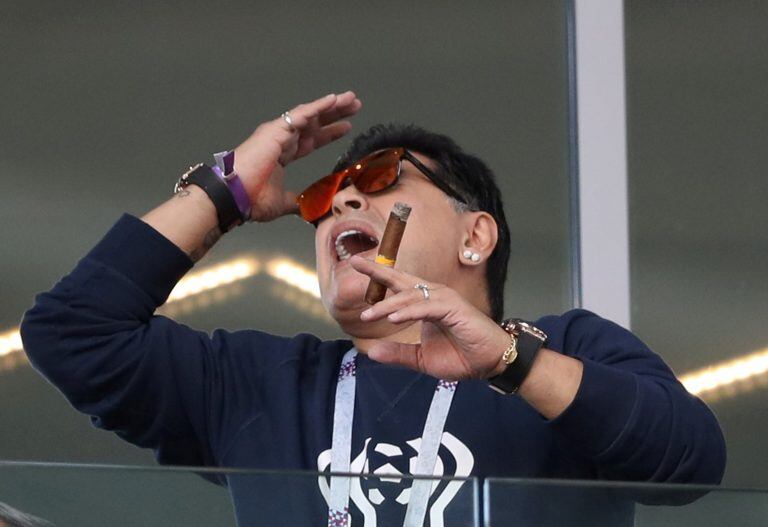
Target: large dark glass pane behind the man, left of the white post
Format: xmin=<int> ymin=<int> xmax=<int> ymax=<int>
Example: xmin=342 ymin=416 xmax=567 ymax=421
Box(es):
xmin=0 ymin=4 xmax=570 ymax=463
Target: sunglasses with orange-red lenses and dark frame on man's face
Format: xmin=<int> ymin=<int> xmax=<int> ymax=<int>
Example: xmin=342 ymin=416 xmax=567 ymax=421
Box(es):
xmin=296 ymin=147 xmax=467 ymax=224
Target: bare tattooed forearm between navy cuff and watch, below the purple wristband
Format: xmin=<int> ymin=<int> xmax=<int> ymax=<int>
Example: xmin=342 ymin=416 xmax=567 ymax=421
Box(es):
xmin=141 ymin=185 xmax=222 ymax=262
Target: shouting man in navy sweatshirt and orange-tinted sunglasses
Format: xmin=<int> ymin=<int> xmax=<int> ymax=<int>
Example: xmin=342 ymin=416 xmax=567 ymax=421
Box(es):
xmin=22 ymin=92 xmax=725 ymax=525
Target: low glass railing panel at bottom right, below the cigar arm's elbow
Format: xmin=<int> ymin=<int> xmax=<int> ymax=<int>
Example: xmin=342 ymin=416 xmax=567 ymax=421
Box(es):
xmin=484 ymin=479 xmax=768 ymax=527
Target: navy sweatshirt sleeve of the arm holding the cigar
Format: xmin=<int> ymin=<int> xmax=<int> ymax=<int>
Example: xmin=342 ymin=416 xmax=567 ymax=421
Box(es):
xmin=538 ymin=310 xmax=725 ymax=484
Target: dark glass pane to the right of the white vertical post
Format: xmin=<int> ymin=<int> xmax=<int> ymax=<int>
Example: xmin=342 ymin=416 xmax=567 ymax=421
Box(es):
xmin=626 ymin=0 xmax=768 ymax=486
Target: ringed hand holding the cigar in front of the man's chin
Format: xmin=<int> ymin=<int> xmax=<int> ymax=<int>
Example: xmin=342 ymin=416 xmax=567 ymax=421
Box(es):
xmin=350 ymin=256 xmax=510 ymax=380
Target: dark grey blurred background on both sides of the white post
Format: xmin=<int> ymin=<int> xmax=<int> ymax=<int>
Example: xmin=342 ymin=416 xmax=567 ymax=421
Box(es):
xmin=0 ymin=0 xmax=768 ymax=500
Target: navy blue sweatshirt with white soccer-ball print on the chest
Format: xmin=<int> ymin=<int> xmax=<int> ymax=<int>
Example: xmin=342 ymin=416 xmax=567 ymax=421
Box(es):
xmin=21 ymin=215 xmax=725 ymax=525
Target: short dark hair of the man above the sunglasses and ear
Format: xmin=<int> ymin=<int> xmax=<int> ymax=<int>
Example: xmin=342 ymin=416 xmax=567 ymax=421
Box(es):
xmin=334 ymin=124 xmax=510 ymax=322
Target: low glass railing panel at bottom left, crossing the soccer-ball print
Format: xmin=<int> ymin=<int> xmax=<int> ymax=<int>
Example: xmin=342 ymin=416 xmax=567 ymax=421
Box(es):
xmin=0 ymin=462 xmax=479 ymax=527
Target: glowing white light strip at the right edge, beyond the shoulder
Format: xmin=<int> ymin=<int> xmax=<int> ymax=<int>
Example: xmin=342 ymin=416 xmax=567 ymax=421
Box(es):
xmin=680 ymin=348 xmax=768 ymax=395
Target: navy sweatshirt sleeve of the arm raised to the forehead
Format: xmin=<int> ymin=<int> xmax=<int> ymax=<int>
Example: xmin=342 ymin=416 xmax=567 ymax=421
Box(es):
xmin=21 ymin=215 xmax=222 ymax=466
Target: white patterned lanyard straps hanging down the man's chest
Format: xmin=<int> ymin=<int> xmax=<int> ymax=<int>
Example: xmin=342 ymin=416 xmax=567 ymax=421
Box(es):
xmin=328 ymin=348 xmax=458 ymax=527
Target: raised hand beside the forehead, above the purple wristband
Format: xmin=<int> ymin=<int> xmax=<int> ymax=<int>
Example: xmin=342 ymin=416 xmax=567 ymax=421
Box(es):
xmin=235 ymin=91 xmax=362 ymax=221
